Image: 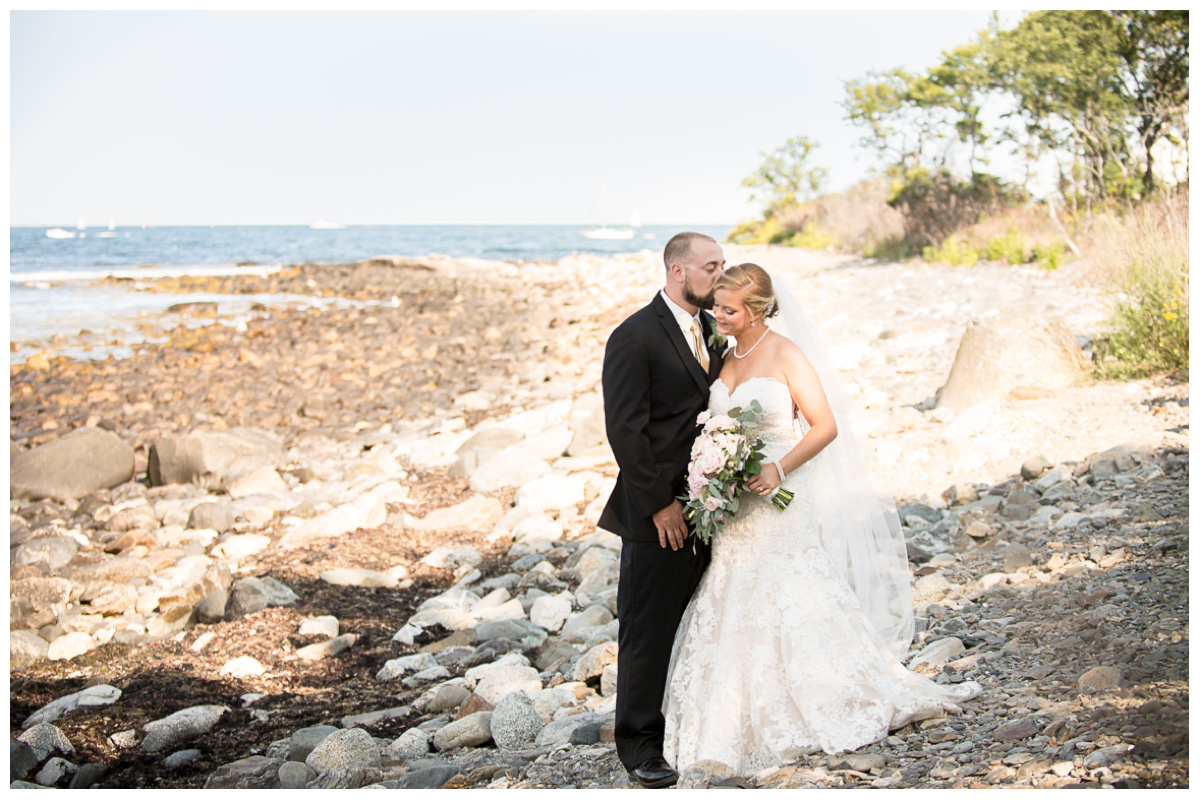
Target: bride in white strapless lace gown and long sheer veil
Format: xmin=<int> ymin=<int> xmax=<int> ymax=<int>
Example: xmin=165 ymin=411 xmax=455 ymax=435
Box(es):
xmin=662 ymin=264 xmax=979 ymax=775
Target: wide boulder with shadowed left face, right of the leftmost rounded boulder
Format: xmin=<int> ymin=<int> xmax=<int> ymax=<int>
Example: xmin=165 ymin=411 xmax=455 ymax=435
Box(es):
xmin=148 ymin=428 xmax=284 ymax=489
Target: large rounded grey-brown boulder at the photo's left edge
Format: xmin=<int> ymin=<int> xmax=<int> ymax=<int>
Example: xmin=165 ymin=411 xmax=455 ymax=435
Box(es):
xmin=8 ymin=428 xmax=133 ymax=500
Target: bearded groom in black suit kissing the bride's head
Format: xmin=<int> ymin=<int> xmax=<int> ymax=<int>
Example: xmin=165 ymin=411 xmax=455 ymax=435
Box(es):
xmin=599 ymin=233 xmax=725 ymax=788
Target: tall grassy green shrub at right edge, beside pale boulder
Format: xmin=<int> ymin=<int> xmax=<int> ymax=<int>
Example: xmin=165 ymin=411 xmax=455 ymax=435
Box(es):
xmin=1096 ymin=198 xmax=1190 ymax=379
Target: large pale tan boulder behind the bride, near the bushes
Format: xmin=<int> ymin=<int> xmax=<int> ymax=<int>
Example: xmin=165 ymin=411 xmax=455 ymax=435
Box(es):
xmin=937 ymin=314 xmax=1088 ymax=414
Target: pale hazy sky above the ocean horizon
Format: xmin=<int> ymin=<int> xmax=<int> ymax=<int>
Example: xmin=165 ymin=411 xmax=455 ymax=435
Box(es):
xmin=10 ymin=11 xmax=1020 ymax=227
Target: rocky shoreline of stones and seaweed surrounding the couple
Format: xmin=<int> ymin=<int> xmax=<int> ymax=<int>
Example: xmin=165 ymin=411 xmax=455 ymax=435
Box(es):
xmin=10 ymin=247 xmax=1188 ymax=788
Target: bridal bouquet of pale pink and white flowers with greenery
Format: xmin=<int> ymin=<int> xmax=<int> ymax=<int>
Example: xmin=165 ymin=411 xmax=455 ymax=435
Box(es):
xmin=679 ymin=401 xmax=796 ymax=545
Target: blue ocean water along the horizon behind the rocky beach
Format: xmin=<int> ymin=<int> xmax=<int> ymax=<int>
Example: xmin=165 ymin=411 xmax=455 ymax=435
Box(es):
xmin=8 ymin=225 xmax=731 ymax=363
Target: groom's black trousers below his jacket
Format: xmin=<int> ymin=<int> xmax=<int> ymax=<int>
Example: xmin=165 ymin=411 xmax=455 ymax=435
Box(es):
xmin=613 ymin=536 xmax=709 ymax=770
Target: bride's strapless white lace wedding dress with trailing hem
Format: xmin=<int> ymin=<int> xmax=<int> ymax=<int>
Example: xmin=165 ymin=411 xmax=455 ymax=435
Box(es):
xmin=664 ymin=377 xmax=979 ymax=775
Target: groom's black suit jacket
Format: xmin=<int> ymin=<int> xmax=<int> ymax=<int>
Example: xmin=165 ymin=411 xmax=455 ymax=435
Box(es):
xmin=600 ymin=293 xmax=721 ymax=542
